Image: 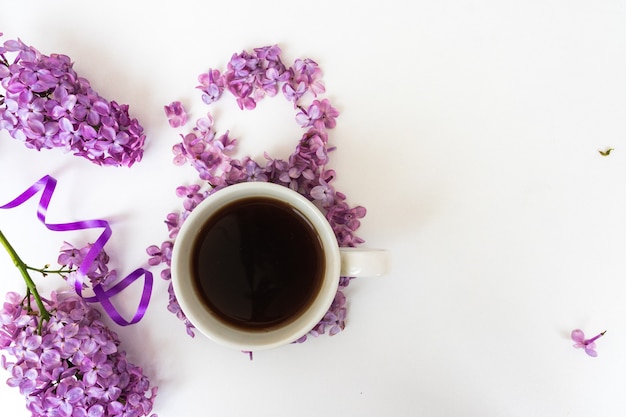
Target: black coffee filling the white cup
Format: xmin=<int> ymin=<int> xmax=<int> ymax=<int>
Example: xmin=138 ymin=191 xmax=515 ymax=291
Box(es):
xmin=192 ymin=197 xmax=325 ymax=330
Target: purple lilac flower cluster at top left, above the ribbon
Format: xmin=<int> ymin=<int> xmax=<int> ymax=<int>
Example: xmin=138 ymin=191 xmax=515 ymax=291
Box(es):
xmin=0 ymin=33 xmax=145 ymax=166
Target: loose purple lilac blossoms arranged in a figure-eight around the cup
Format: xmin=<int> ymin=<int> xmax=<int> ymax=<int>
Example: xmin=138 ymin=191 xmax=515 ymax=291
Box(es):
xmin=147 ymin=45 xmax=366 ymax=342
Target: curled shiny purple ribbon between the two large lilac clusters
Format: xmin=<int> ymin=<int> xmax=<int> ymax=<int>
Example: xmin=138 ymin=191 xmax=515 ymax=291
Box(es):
xmin=0 ymin=175 xmax=153 ymax=326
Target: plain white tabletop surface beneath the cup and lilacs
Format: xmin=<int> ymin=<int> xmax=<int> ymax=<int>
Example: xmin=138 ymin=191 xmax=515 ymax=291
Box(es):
xmin=0 ymin=0 xmax=626 ymax=417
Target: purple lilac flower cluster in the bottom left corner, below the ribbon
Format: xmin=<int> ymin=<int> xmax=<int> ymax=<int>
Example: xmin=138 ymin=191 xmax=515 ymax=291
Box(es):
xmin=0 ymin=293 xmax=157 ymax=417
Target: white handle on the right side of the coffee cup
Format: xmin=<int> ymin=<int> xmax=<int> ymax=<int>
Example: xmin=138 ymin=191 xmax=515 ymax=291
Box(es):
xmin=339 ymin=248 xmax=389 ymax=277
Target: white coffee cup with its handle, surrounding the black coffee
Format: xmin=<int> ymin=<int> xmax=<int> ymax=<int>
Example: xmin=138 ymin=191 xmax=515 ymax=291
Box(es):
xmin=172 ymin=182 xmax=388 ymax=351
